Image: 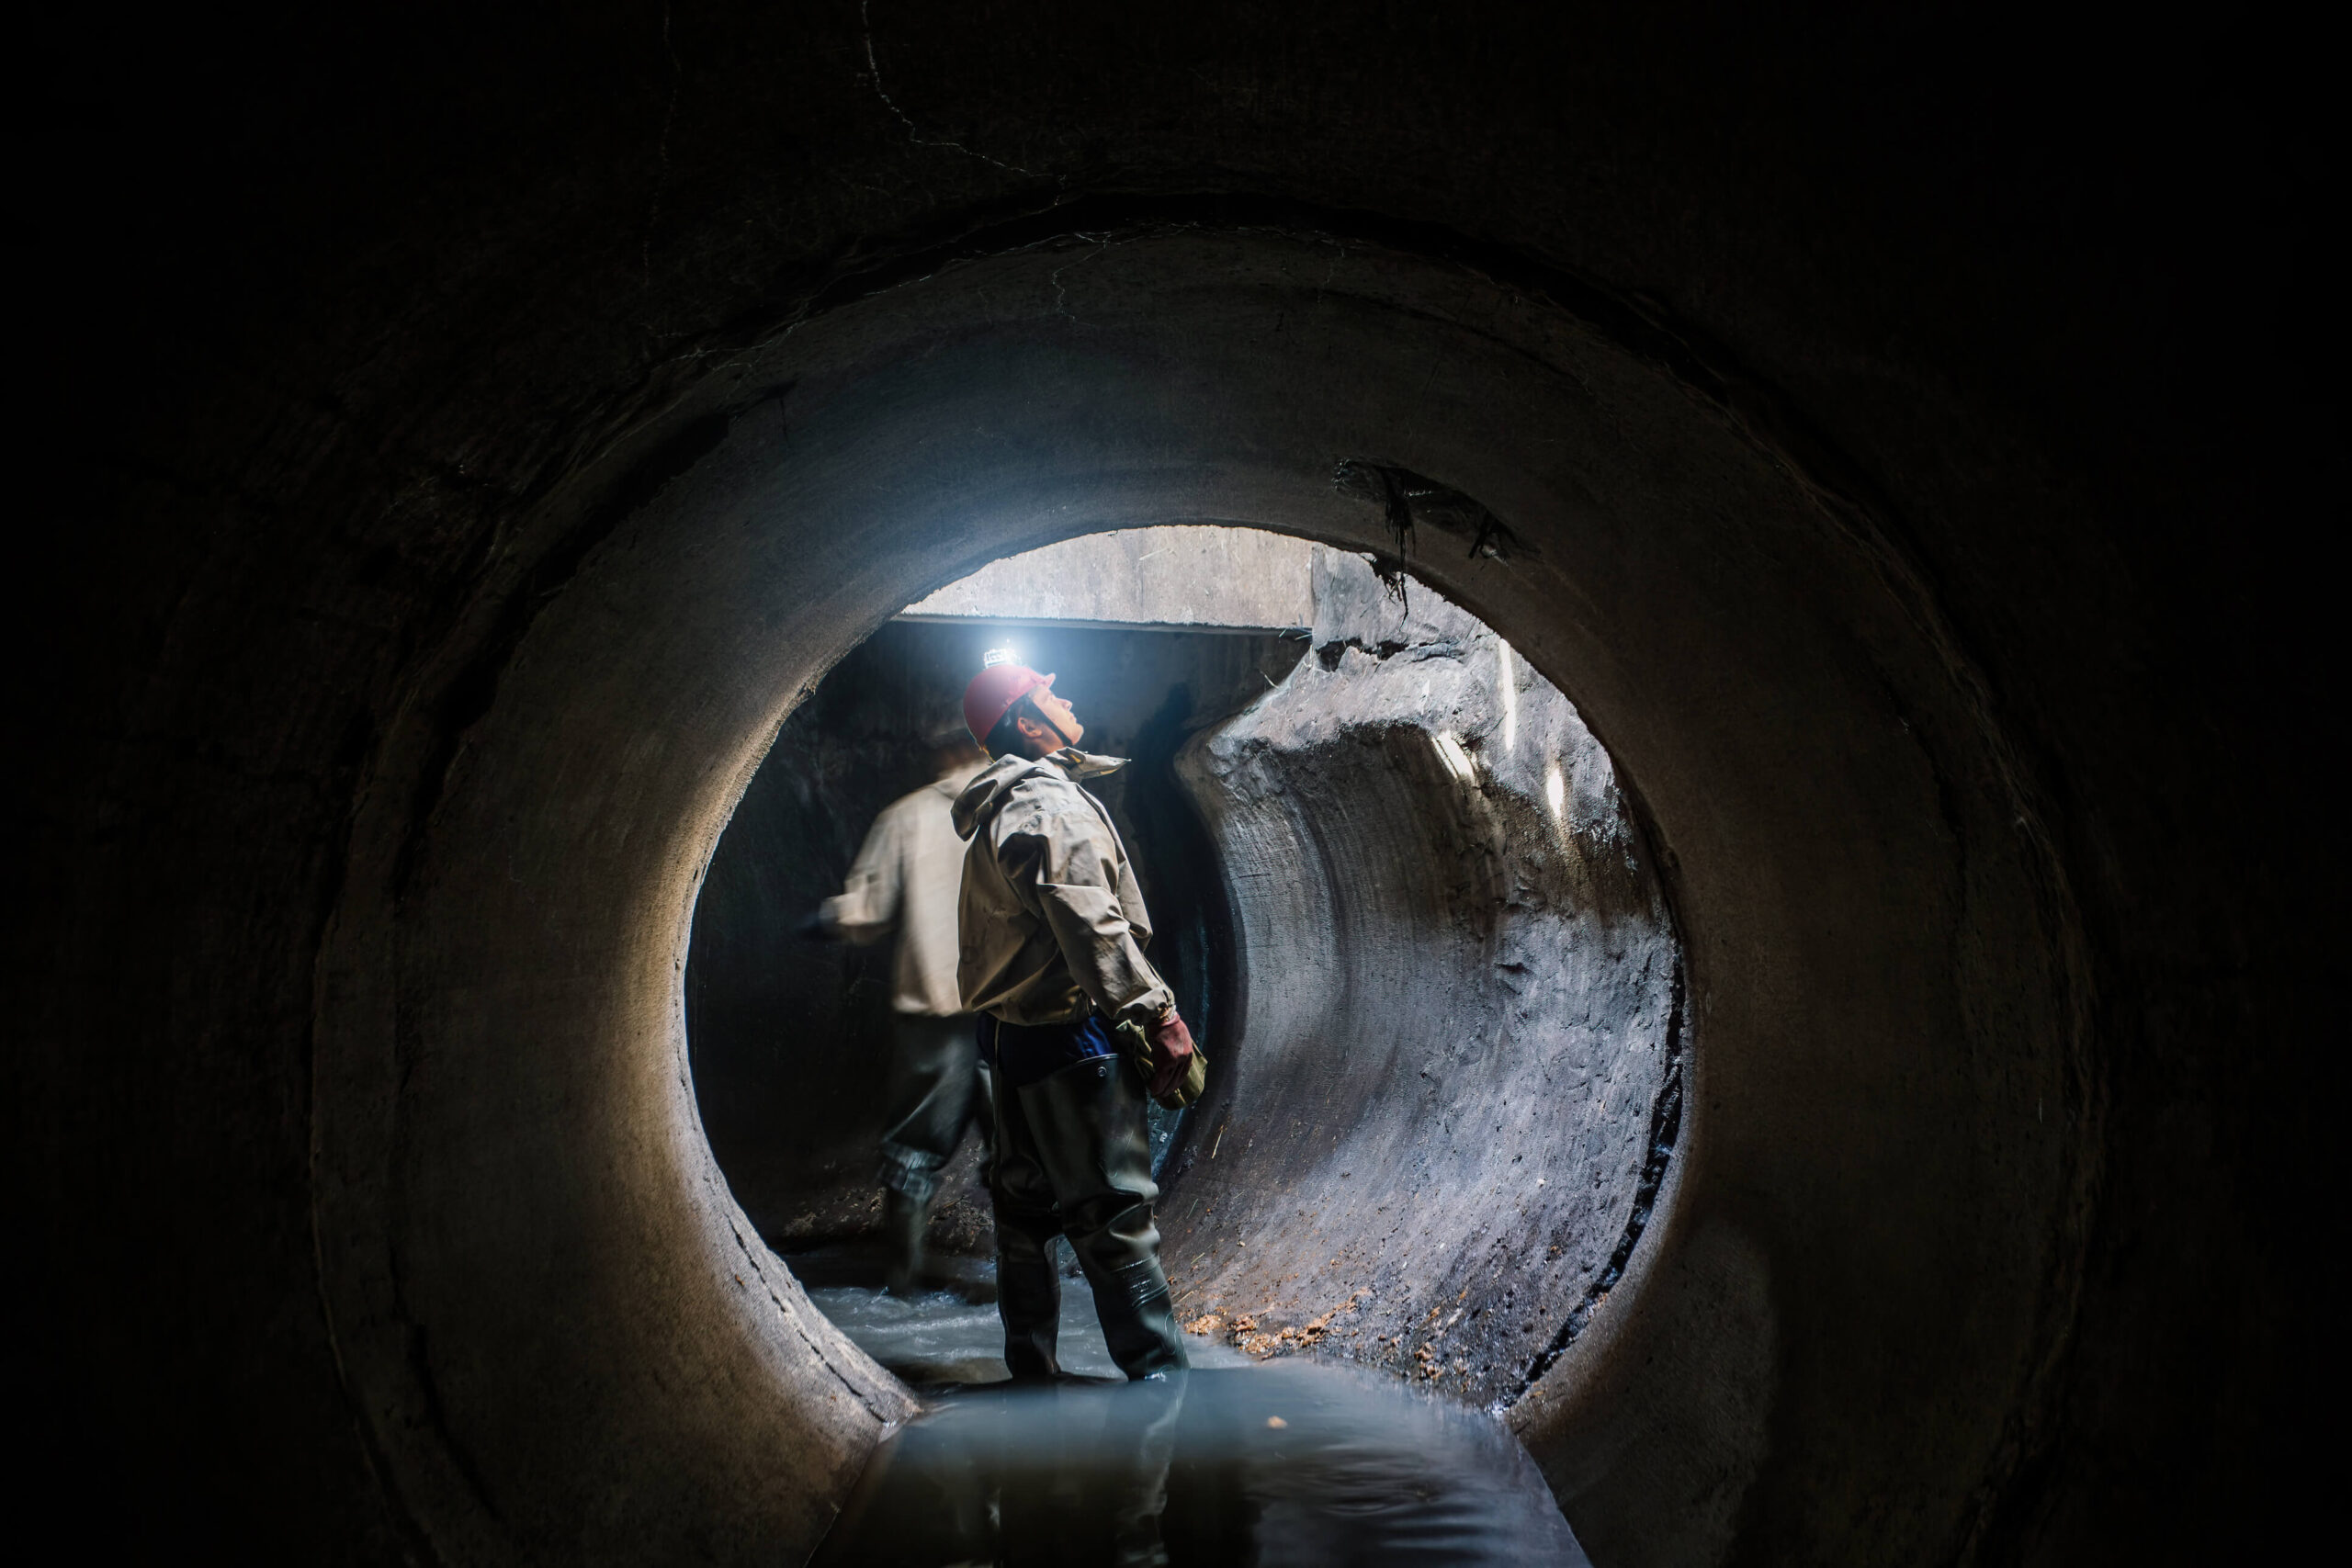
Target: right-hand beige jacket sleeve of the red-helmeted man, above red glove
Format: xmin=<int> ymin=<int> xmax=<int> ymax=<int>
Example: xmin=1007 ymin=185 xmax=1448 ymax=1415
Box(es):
xmin=997 ymin=811 xmax=1176 ymax=1022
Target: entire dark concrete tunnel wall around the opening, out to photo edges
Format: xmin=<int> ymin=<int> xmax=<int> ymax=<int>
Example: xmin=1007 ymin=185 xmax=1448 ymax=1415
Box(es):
xmin=9 ymin=7 xmax=2338 ymax=1563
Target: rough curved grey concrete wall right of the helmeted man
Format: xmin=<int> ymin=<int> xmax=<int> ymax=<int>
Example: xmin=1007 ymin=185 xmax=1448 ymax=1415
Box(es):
xmin=1162 ymin=546 xmax=1684 ymax=1408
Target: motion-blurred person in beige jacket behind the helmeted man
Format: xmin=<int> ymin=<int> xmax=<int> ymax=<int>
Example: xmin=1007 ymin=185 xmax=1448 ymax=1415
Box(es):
xmin=809 ymin=728 xmax=988 ymax=1295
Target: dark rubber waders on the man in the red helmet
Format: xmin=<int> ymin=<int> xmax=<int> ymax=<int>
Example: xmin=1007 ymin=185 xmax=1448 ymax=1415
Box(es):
xmin=981 ymin=1021 xmax=1185 ymax=1380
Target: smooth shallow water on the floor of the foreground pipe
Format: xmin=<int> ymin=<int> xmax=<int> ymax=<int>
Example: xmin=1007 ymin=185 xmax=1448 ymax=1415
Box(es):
xmin=814 ymin=1361 xmax=1588 ymax=1568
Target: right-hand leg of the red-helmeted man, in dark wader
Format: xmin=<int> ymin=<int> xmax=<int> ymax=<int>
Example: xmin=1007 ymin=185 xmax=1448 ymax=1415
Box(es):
xmin=1012 ymin=1055 xmax=1185 ymax=1378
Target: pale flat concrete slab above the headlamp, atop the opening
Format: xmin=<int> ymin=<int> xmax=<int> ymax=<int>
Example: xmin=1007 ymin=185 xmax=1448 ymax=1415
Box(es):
xmin=906 ymin=525 xmax=1312 ymax=630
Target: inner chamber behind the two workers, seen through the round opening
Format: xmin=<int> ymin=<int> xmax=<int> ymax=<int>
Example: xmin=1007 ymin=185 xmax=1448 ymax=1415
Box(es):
xmin=687 ymin=529 xmax=1687 ymax=1411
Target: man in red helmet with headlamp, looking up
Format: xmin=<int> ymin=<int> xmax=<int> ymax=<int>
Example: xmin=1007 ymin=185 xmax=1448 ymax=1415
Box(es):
xmin=955 ymin=651 xmax=1202 ymax=1380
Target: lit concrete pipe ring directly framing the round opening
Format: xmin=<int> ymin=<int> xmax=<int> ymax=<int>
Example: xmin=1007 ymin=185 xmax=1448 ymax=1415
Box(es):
xmin=253 ymin=232 xmax=2088 ymax=1561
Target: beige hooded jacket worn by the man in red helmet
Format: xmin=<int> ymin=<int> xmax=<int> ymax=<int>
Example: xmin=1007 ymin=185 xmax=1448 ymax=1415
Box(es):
xmin=953 ymin=748 xmax=1176 ymax=1025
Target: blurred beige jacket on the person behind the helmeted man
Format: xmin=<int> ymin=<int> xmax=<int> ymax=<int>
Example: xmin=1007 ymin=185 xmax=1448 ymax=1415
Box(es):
xmin=819 ymin=766 xmax=981 ymax=1018
